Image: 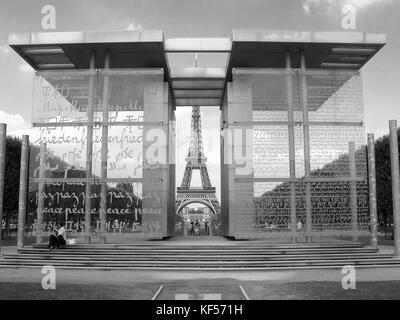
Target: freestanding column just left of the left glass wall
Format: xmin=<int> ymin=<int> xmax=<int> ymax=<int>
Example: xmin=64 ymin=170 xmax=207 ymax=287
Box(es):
xmin=17 ymin=135 xmax=29 ymax=248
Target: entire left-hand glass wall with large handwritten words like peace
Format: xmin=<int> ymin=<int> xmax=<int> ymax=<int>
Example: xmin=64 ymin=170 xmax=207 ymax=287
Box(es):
xmin=27 ymin=70 xmax=170 ymax=242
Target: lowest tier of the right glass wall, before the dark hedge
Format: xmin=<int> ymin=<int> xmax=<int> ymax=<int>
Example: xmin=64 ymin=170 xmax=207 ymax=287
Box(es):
xmin=235 ymin=181 xmax=369 ymax=236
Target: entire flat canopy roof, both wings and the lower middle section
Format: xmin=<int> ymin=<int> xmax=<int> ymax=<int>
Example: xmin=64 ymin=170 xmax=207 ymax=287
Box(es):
xmin=9 ymin=30 xmax=386 ymax=106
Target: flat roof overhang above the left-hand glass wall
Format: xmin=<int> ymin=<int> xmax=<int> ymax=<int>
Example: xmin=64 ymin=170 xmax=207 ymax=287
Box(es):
xmin=9 ymin=31 xmax=168 ymax=77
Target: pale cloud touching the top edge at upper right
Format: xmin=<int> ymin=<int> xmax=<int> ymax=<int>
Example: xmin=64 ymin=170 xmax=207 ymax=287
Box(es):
xmin=303 ymin=0 xmax=394 ymax=14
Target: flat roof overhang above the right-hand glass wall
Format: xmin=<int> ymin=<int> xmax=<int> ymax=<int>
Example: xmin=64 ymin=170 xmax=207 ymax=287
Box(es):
xmin=227 ymin=30 xmax=386 ymax=80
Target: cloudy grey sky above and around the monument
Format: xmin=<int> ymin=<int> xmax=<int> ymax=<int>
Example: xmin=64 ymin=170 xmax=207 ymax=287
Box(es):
xmin=0 ymin=0 xmax=400 ymax=200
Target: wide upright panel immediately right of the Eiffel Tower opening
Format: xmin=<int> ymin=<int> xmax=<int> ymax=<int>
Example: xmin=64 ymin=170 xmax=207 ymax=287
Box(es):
xmin=224 ymin=79 xmax=255 ymax=237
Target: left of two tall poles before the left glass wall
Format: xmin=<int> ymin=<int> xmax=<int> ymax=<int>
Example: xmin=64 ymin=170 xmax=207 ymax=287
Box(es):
xmin=85 ymin=51 xmax=96 ymax=243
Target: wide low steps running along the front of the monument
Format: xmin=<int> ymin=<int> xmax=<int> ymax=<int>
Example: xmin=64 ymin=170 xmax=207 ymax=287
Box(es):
xmin=0 ymin=241 xmax=400 ymax=271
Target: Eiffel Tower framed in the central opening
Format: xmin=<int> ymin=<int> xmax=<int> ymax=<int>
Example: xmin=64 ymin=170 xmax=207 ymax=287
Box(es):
xmin=175 ymin=106 xmax=221 ymax=215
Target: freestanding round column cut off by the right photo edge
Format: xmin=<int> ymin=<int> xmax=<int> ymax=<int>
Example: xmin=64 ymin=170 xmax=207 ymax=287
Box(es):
xmin=389 ymin=120 xmax=400 ymax=257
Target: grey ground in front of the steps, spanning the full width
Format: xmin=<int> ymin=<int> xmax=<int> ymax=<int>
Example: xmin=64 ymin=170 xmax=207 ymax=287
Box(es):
xmin=0 ymin=250 xmax=400 ymax=300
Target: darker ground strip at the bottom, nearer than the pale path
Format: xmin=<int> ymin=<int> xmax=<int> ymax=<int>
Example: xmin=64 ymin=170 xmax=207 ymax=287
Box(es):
xmin=0 ymin=279 xmax=400 ymax=300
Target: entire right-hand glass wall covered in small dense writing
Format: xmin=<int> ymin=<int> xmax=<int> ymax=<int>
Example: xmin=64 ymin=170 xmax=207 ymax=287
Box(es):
xmin=228 ymin=69 xmax=369 ymax=237
